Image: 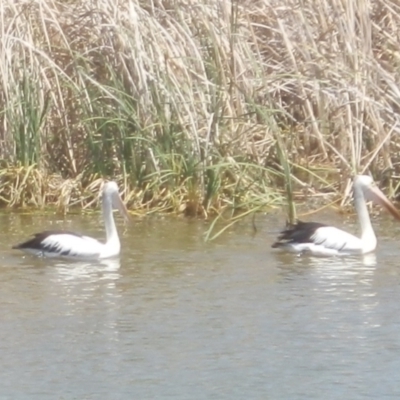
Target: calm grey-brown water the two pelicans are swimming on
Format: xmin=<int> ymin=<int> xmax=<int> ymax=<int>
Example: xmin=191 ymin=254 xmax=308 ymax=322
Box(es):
xmin=0 ymin=211 xmax=400 ymax=400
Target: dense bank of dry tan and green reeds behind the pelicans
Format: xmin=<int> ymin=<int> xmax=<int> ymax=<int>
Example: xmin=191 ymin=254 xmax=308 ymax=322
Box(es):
xmin=0 ymin=0 xmax=400 ymax=217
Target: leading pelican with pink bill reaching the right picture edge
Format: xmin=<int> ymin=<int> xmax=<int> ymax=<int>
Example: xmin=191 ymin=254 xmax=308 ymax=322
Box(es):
xmin=272 ymin=175 xmax=400 ymax=256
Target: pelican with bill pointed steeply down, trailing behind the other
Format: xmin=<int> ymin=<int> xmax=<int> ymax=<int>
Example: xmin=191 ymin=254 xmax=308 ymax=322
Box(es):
xmin=13 ymin=182 xmax=129 ymax=260
